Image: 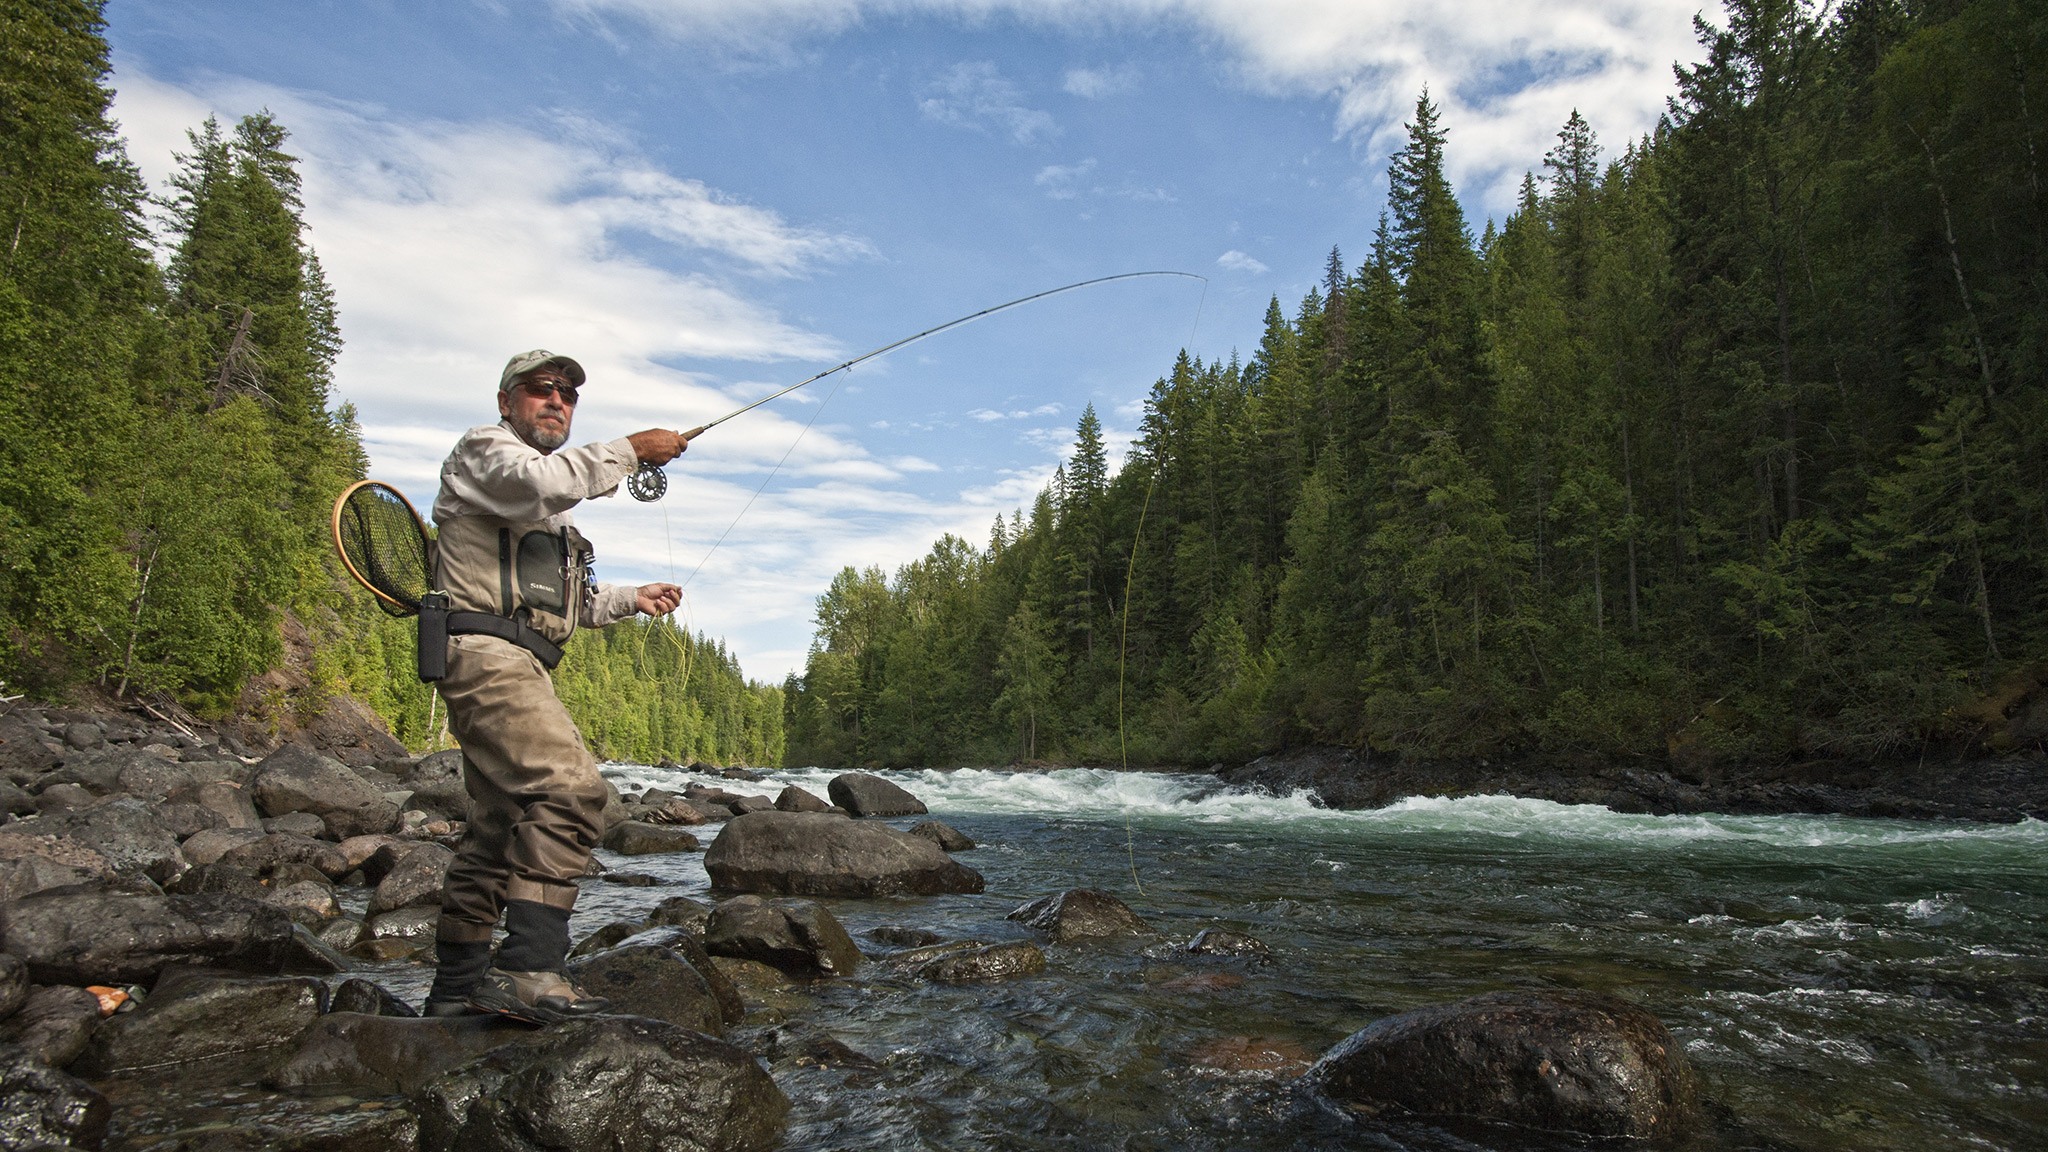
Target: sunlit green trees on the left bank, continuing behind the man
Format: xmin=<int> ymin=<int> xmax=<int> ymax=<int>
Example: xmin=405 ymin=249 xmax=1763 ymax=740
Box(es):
xmin=0 ymin=0 xmax=782 ymax=763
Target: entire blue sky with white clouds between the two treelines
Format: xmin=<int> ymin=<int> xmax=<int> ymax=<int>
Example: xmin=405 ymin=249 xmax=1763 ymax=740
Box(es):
xmin=106 ymin=0 xmax=1718 ymax=678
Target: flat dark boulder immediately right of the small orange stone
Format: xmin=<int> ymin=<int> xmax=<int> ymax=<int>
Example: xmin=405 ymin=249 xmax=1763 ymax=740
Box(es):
xmin=72 ymin=968 xmax=328 ymax=1080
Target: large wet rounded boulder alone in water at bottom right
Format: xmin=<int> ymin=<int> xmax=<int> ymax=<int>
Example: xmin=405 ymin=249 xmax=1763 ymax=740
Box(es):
xmin=1303 ymin=992 xmax=1700 ymax=1140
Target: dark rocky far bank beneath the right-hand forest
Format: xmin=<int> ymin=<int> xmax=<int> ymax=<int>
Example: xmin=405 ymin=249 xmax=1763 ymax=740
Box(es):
xmin=1210 ymin=746 xmax=2048 ymax=824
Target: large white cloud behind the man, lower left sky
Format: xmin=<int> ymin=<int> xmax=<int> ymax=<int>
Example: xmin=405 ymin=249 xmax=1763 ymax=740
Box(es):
xmin=99 ymin=64 xmax=987 ymax=678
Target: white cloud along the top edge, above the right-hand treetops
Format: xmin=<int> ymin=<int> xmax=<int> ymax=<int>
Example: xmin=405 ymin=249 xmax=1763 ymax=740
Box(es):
xmin=553 ymin=0 xmax=1720 ymax=205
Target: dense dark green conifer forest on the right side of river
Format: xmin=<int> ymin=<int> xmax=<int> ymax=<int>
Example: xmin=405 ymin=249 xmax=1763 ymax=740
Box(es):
xmin=786 ymin=0 xmax=2048 ymax=765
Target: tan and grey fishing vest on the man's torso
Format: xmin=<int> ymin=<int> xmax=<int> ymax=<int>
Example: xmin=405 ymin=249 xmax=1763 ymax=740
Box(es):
xmin=434 ymin=517 xmax=596 ymax=668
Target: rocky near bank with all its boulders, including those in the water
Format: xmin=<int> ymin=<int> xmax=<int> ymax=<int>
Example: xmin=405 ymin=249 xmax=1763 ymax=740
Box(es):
xmin=0 ymin=696 xmax=1728 ymax=1152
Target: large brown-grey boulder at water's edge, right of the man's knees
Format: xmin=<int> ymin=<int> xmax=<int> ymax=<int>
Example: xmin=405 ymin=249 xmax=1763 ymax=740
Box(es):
xmin=705 ymin=812 xmax=981 ymax=896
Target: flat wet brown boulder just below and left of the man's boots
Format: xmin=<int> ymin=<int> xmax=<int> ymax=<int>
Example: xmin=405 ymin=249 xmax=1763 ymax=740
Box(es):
xmin=264 ymin=1011 xmax=520 ymax=1090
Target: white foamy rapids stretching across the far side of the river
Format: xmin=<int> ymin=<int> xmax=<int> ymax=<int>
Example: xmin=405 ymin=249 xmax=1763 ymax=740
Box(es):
xmin=608 ymin=765 xmax=2048 ymax=869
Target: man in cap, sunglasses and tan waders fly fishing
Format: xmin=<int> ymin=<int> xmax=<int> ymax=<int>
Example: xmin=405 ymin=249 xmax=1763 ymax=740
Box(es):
xmin=426 ymin=351 xmax=690 ymax=1023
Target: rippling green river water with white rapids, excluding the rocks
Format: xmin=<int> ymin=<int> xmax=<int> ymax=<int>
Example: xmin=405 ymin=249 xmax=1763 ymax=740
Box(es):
xmin=436 ymin=765 xmax=2048 ymax=1152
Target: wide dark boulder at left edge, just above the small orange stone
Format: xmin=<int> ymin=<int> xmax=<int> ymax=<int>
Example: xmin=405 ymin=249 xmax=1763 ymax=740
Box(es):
xmin=0 ymin=888 xmax=291 ymax=984
